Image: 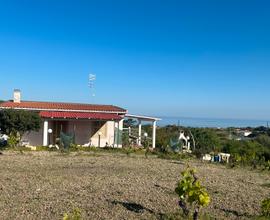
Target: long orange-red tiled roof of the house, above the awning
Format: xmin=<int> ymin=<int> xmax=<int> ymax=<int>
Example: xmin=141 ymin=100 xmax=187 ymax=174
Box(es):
xmin=0 ymin=101 xmax=127 ymax=114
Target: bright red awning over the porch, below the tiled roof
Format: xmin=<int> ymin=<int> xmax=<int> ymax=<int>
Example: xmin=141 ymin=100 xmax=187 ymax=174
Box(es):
xmin=39 ymin=111 xmax=122 ymax=121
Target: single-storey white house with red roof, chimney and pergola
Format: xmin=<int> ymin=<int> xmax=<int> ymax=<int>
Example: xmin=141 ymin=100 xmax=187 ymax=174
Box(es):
xmin=0 ymin=90 xmax=159 ymax=148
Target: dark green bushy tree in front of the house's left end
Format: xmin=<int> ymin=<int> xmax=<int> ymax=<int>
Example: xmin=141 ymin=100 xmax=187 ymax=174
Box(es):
xmin=0 ymin=109 xmax=41 ymax=146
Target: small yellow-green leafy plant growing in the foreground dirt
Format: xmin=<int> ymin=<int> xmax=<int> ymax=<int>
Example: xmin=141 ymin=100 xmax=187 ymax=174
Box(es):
xmin=175 ymin=167 xmax=210 ymax=220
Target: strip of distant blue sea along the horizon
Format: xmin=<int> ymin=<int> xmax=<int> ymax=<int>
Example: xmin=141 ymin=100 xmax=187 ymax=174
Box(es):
xmin=158 ymin=117 xmax=270 ymax=128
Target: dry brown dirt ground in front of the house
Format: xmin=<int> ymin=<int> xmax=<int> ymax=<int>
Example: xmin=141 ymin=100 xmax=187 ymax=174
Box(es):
xmin=0 ymin=152 xmax=270 ymax=219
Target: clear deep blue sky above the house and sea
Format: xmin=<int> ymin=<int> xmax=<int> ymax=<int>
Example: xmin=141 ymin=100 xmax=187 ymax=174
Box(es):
xmin=0 ymin=0 xmax=270 ymax=119
